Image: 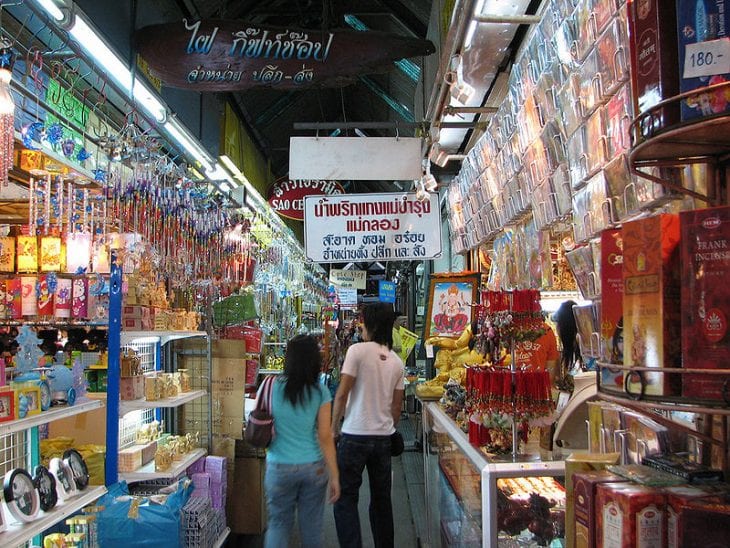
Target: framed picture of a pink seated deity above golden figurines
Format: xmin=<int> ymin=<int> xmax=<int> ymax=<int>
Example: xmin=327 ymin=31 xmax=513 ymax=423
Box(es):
xmin=424 ymin=272 xmax=481 ymax=339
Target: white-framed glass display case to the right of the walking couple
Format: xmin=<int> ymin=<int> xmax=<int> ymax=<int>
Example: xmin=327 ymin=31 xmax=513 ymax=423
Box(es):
xmin=423 ymin=402 xmax=565 ymax=547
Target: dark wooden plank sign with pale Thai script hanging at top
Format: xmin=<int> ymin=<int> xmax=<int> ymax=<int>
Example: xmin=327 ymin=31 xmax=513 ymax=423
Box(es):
xmin=136 ymin=19 xmax=435 ymax=91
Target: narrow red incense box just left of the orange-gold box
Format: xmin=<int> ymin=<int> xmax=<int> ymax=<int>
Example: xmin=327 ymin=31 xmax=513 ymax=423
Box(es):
xmin=601 ymin=229 xmax=624 ymax=391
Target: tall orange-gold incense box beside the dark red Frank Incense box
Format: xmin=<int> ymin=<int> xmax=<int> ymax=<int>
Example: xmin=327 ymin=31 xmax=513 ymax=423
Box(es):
xmin=623 ymin=214 xmax=681 ymax=396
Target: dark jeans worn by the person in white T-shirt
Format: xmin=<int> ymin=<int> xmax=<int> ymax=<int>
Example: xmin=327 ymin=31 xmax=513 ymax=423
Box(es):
xmin=335 ymin=434 xmax=393 ymax=548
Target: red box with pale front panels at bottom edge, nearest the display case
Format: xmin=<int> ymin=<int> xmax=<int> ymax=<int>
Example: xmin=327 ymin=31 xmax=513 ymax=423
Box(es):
xmin=596 ymin=483 xmax=666 ymax=548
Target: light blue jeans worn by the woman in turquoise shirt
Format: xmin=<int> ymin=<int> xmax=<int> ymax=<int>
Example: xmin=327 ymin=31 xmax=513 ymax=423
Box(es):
xmin=264 ymin=461 xmax=329 ymax=548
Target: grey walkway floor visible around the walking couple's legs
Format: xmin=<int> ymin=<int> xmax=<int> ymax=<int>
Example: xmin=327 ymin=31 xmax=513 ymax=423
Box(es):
xmin=226 ymin=415 xmax=425 ymax=548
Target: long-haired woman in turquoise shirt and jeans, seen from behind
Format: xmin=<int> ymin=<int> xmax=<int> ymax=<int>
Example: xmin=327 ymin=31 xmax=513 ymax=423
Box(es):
xmin=264 ymin=335 xmax=340 ymax=548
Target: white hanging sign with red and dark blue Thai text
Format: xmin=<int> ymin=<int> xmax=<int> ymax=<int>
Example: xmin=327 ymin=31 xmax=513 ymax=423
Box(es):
xmin=304 ymin=193 xmax=441 ymax=263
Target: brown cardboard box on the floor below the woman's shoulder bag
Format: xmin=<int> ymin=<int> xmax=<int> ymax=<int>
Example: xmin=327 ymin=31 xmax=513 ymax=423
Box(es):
xmin=226 ymin=458 xmax=266 ymax=535
